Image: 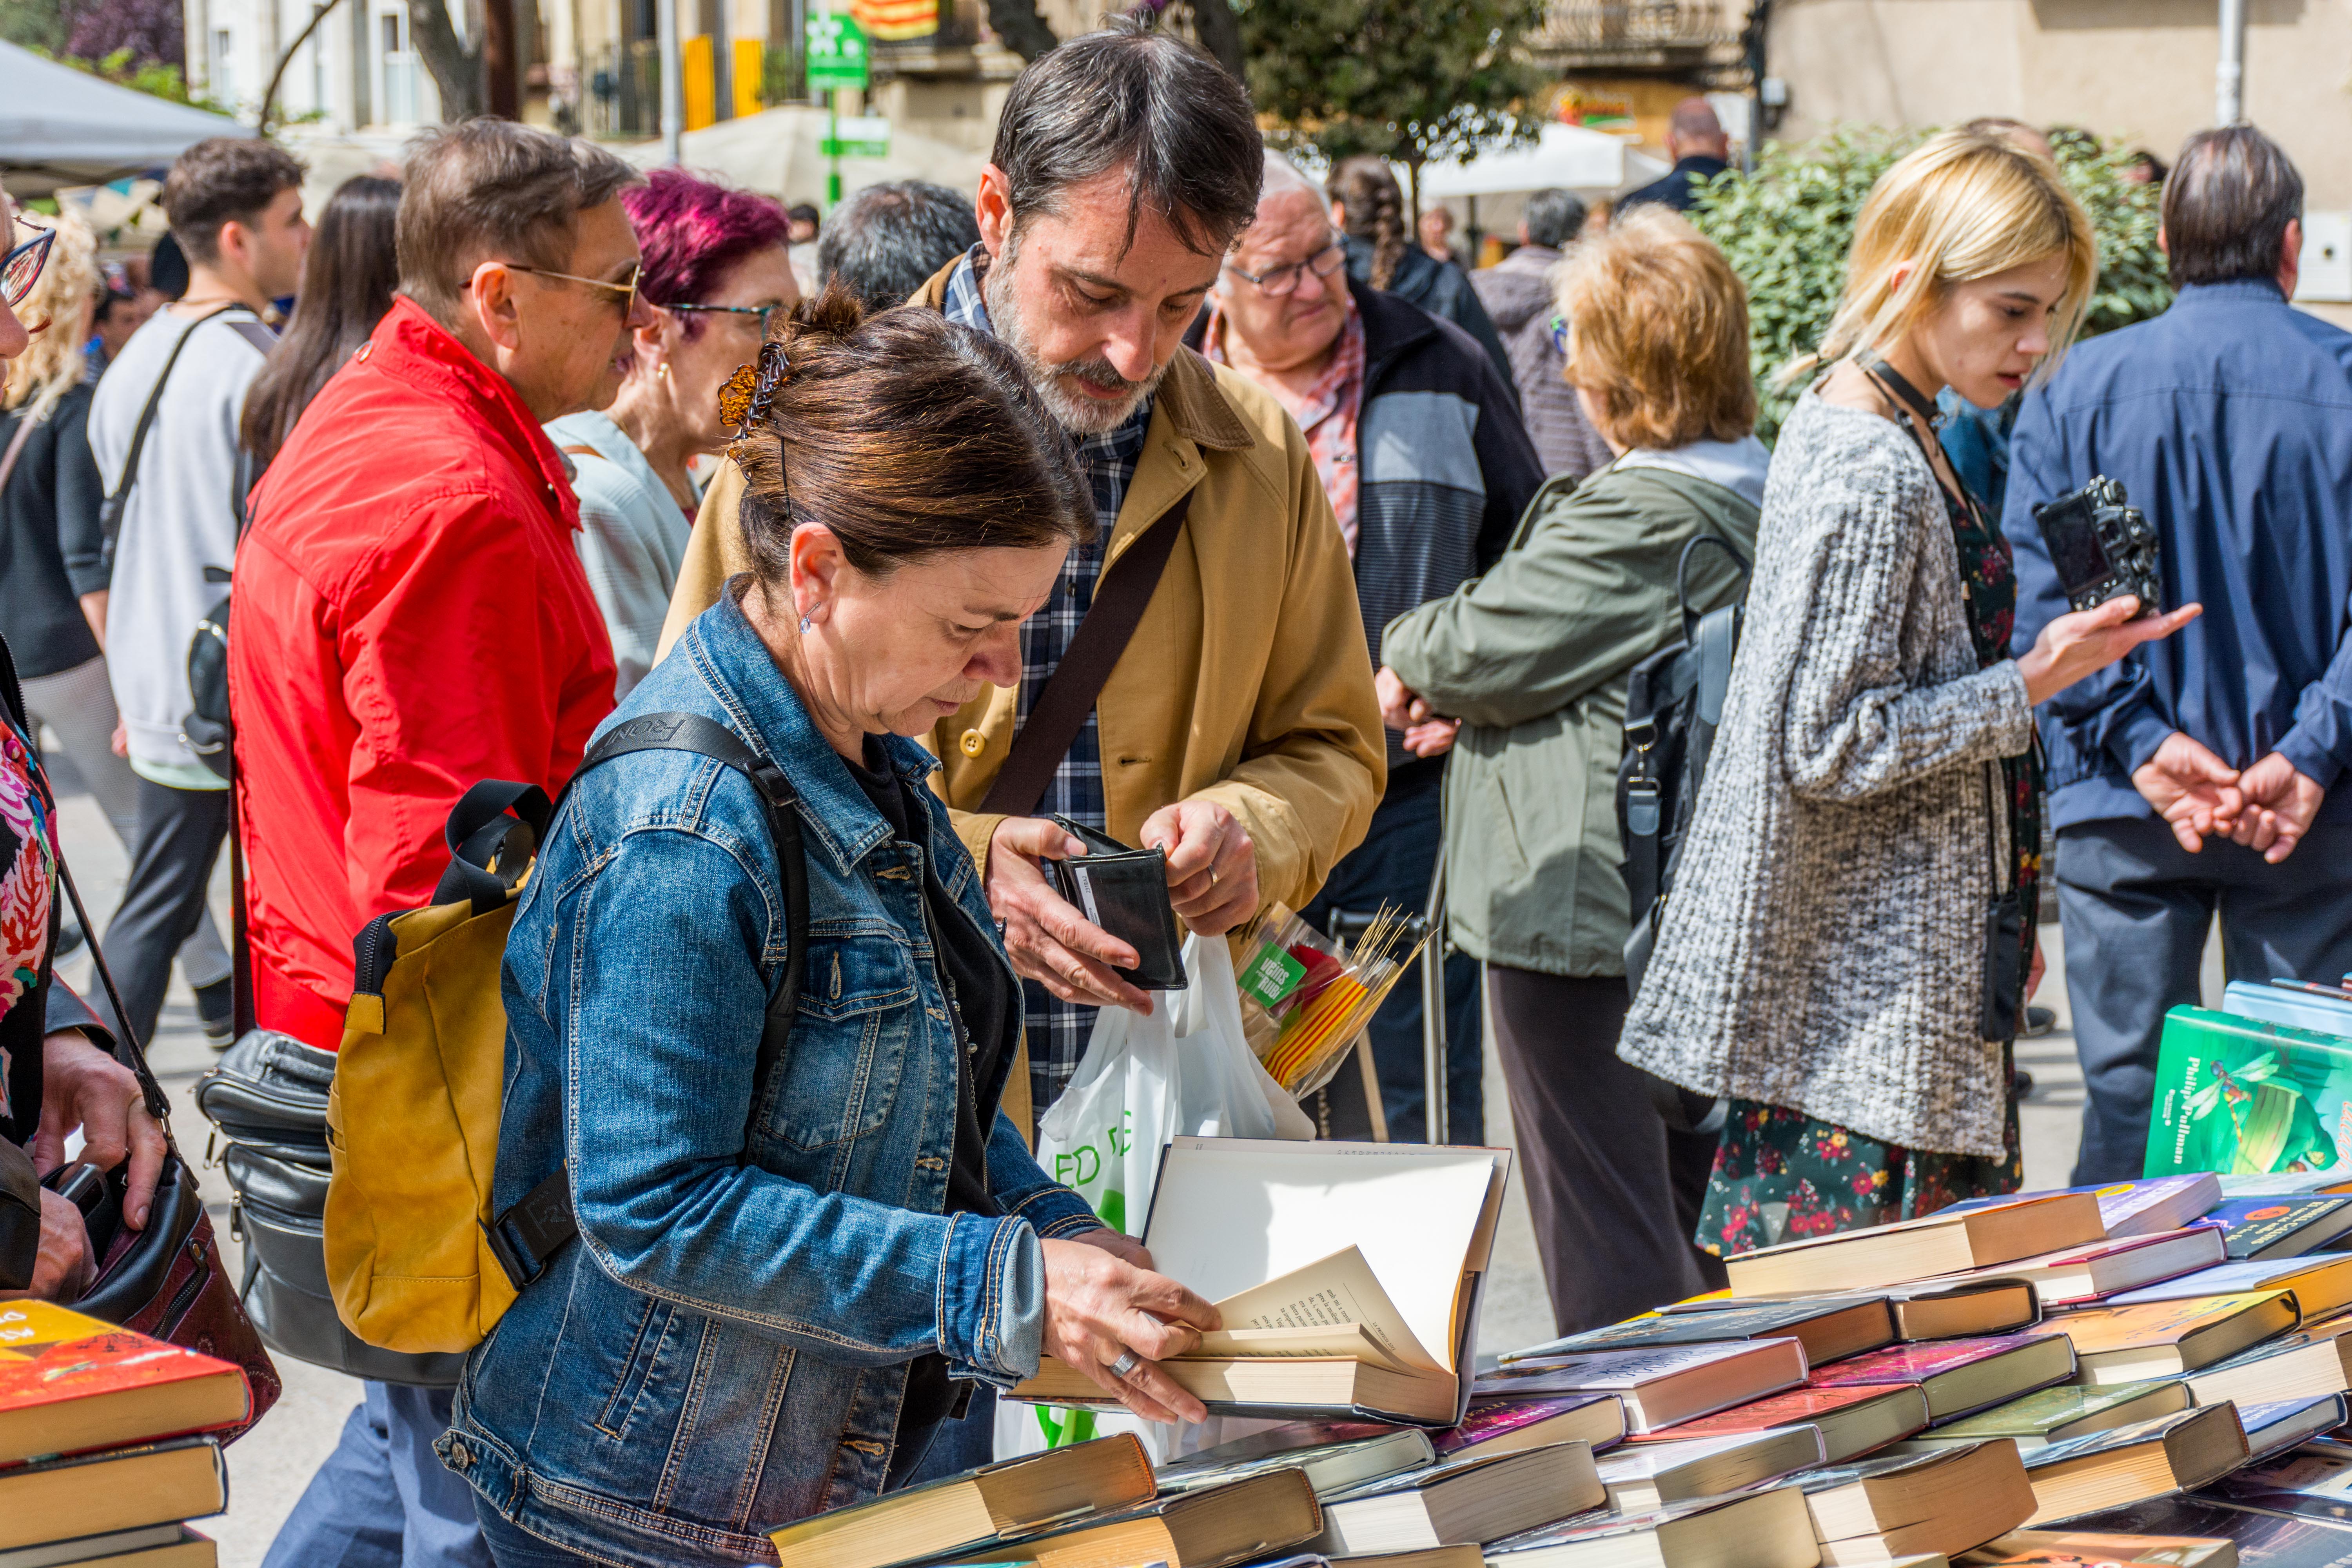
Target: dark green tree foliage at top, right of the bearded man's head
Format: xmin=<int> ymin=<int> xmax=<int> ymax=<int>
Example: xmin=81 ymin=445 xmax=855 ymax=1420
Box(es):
xmin=1235 ymin=0 xmax=1543 ymax=196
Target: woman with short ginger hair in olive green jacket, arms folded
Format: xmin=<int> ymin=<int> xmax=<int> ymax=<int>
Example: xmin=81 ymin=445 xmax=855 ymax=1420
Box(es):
xmin=1381 ymin=209 xmax=1766 ymax=1333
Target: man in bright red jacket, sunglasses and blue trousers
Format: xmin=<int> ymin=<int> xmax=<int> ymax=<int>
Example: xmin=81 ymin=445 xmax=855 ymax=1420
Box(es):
xmin=228 ymin=120 xmax=652 ymax=1568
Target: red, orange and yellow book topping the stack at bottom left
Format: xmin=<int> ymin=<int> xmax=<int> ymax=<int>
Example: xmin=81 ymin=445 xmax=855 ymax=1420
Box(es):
xmin=0 ymin=1300 xmax=254 ymax=1465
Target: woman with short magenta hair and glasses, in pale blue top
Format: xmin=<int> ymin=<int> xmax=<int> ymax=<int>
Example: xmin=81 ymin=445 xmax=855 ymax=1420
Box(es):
xmin=548 ymin=169 xmax=800 ymax=698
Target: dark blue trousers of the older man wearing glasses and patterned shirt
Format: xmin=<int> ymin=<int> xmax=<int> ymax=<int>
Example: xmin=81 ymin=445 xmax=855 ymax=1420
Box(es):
xmin=1301 ymin=757 xmax=1486 ymax=1143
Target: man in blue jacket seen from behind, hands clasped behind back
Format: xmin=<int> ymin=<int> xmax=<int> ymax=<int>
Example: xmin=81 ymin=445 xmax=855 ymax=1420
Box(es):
xmin=2002 ymin=125 xmax=2352 ymax=1182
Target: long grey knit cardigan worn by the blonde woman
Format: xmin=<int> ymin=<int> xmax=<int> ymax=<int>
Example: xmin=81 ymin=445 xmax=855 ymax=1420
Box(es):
xmin=1618 ymin=392 xmax=2032 ymax=1157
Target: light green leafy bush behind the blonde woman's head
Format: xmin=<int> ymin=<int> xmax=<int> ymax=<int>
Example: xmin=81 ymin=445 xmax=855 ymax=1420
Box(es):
xmin=1691 ymin=127 xmax=2173 ymax=442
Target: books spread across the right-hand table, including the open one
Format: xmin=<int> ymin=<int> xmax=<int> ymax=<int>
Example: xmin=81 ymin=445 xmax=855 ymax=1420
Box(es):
xmin=753 ymin=1067 xmax=2352 ymax=1568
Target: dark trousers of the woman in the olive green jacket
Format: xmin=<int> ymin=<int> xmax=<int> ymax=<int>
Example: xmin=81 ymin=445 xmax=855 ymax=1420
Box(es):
xmin=1486 ymin=964 xmax=1719 ymax=1333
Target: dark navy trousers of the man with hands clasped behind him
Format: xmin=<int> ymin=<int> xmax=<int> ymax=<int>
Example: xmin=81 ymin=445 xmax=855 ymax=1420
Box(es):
xmin=2058 ymin=818 xmax=2352 ymax=1185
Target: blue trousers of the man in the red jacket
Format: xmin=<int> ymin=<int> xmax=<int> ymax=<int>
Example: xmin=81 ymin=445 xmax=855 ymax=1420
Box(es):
xmin=261 ymin=1382 xmax=492 ymax=1568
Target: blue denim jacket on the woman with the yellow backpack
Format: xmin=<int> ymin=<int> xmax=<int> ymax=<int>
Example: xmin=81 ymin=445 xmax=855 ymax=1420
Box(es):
xmin=440 ymin=595 xmax=1098 ymax=1563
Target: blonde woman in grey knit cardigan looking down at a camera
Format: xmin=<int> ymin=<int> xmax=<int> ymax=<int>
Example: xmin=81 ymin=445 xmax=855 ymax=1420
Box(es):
xmin=1618 ymin=132 xmax=2197 ymax=1255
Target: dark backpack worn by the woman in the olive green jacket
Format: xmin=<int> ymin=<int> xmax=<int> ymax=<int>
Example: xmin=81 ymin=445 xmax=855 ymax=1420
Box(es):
xmin=1616 ymin=534 xmax=1748 ymax=992
